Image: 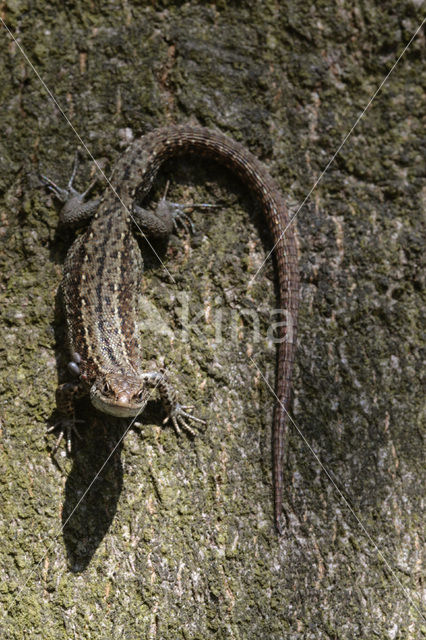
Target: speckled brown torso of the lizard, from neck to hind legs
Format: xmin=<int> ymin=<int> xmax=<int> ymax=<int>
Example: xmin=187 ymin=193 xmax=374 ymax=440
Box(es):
xmin=62 ymin=204 xmax=143 ymax=384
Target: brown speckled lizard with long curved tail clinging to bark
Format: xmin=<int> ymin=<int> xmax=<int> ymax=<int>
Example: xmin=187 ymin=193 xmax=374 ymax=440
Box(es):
xmin=42 ymin=125 xmax=299 ymax=532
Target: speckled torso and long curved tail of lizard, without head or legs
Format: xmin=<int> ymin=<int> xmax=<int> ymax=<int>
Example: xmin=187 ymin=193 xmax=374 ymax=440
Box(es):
xmin=62 ymin=126 xmax=299 ymax=530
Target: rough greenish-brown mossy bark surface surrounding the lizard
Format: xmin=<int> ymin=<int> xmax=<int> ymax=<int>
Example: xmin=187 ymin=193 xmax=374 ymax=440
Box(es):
xmin=0 ymin=0 xmax=425 ymax=640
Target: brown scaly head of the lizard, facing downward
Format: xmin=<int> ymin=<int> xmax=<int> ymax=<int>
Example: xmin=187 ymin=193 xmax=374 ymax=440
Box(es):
xmin=90 ymin=372 xmax=150 ymax=418
